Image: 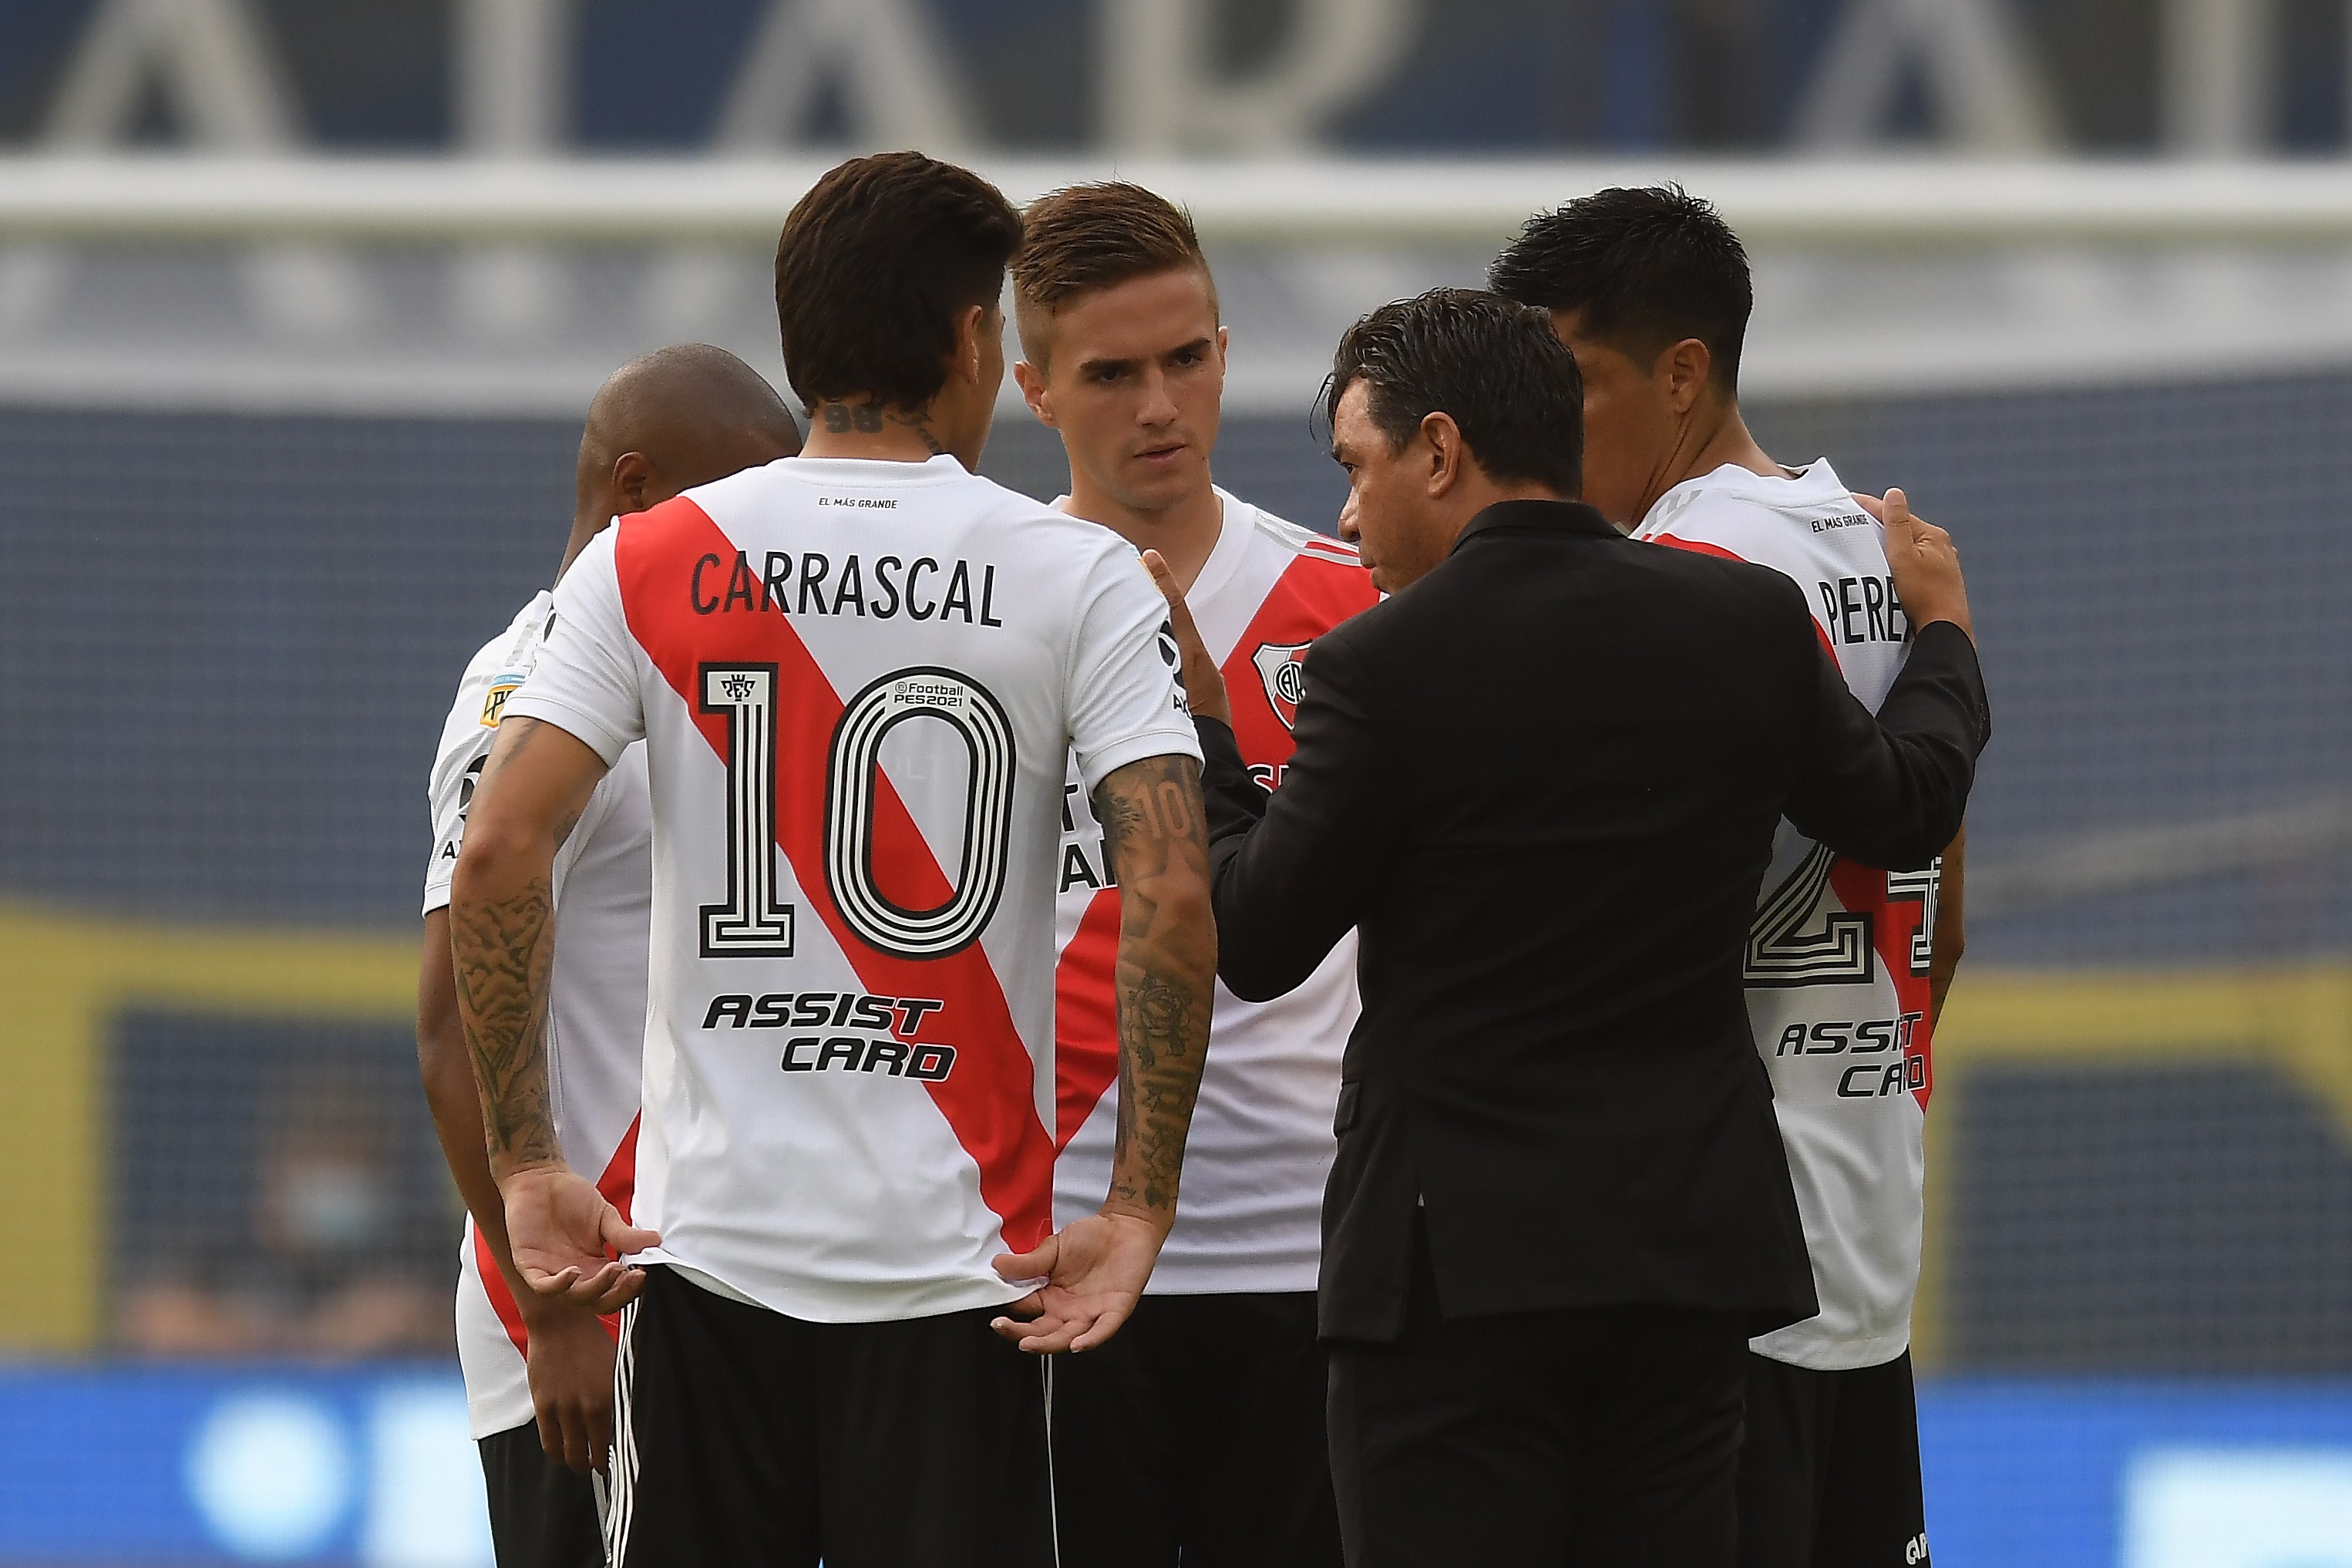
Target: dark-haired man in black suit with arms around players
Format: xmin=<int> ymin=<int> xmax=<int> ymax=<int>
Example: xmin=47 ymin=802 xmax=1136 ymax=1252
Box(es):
xmin=1148 ymin=289 xmax=1990 ymax=1568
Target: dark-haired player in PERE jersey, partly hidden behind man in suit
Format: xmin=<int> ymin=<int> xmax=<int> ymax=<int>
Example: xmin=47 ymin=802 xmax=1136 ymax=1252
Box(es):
xmin=1491 ymin=188 xmax=1962 ymax=1568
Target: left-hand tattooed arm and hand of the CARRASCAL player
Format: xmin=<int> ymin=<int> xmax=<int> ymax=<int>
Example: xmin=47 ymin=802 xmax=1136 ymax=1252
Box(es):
xmin=449 ymin=717 xmax=658 ymax=1312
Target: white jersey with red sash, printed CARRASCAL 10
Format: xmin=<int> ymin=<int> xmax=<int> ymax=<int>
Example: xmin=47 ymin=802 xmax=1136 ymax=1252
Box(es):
xmin=506 ymin=456 xmax=1200 ymax=1321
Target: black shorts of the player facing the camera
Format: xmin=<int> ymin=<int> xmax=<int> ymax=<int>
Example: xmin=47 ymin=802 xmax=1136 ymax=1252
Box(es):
xmin=1052 ymin=1290 xmax=1338 ymax=1568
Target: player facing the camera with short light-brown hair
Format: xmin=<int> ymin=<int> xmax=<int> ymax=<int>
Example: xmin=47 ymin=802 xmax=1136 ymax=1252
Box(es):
xmin=1014 ymin=183 xmax=1378 ymax=1568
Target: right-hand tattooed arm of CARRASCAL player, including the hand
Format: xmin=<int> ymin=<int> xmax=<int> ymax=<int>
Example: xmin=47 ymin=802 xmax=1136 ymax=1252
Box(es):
xmin=998 ymin=757 xmax=1216 ymax=1354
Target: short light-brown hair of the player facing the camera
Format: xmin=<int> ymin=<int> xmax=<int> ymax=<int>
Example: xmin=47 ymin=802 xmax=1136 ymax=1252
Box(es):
xmin=1014 ymin=179 xmax=1216 ymax=365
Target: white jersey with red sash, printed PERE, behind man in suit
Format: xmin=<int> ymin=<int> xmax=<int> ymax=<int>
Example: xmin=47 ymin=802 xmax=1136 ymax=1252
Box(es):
xmin=1634 ymin=461 xmax=1936 ymax=1371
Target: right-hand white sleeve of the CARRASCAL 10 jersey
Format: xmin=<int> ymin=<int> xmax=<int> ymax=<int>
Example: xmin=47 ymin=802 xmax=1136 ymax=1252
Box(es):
xmin=1063 ymin=545 xmax=1200 ymax=797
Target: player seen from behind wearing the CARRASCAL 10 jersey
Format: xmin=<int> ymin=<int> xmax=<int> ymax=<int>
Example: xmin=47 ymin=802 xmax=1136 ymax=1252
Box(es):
xmin=449 ymin=153 xmax=1216 ymax=1568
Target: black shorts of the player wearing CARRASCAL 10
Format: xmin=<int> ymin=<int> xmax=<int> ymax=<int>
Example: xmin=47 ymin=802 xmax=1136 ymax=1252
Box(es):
xmin=607 ymin=1267 xmax=1054 ymax=1568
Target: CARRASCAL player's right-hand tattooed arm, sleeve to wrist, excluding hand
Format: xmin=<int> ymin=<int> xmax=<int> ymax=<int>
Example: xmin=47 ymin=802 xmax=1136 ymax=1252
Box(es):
xmin=1094 ymin=757 xmax=1216 ymax=1220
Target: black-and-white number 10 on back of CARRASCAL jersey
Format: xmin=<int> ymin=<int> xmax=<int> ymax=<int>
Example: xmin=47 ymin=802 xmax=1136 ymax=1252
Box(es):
xmin=698 ymin=663 xmax=1014 ymax=959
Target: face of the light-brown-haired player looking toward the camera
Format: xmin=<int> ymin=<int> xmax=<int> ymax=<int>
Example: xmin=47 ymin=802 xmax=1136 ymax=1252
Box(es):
xmin=1023 ymin=268 xmax=1226 ymax=513
